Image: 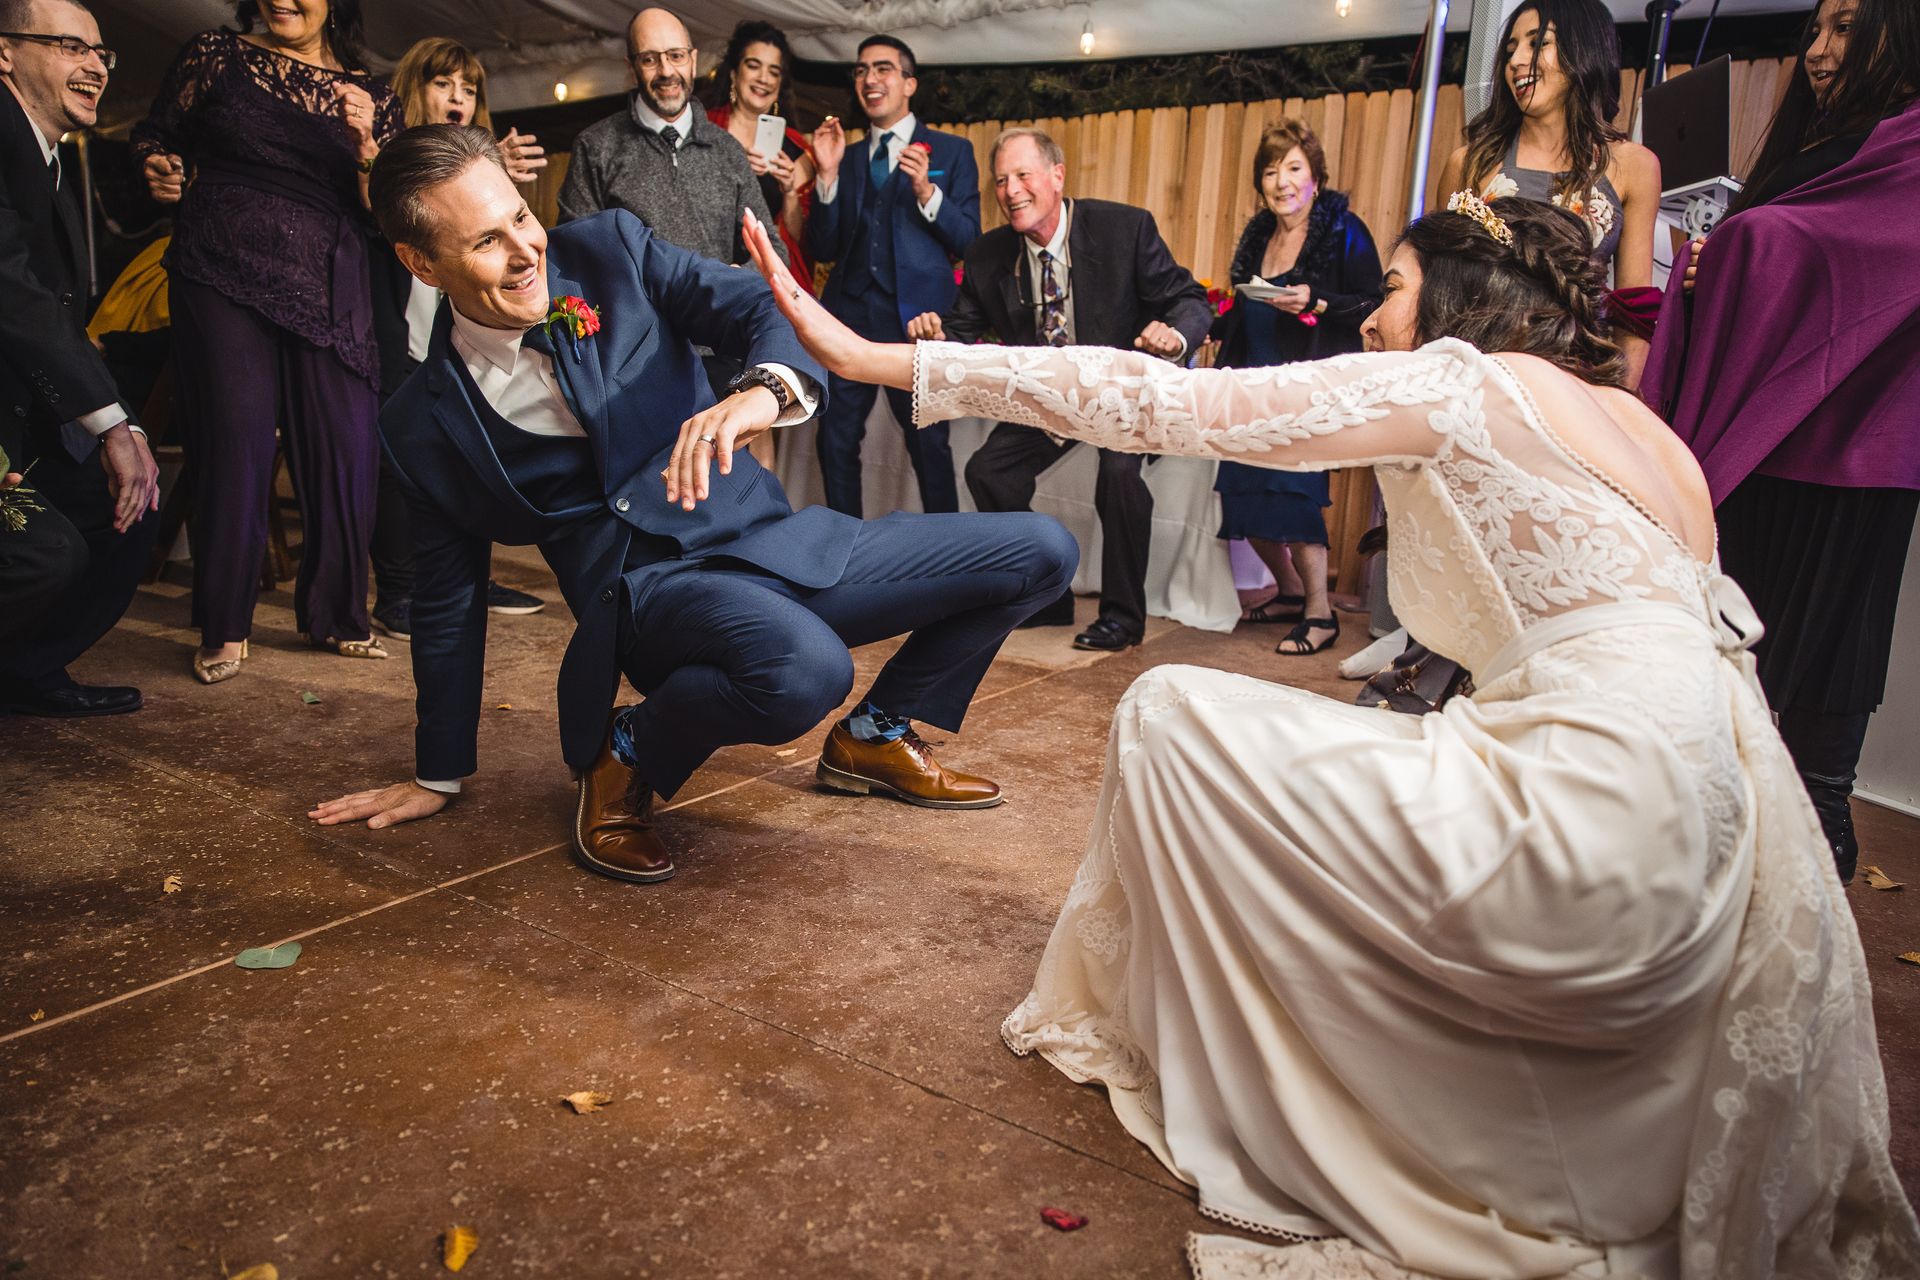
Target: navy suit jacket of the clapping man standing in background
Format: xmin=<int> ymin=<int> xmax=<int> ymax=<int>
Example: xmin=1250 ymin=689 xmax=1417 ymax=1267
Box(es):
xmin=806 ymin=121 xmax=979 ymax=326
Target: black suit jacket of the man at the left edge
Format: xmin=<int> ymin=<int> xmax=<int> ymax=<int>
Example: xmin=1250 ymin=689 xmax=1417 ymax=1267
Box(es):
xmin=0 ymin=86 xmax=119 ymax=459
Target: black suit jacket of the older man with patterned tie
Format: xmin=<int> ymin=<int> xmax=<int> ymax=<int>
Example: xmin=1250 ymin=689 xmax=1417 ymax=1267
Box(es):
xmin=941 ymin=200 xmax=1213 ymax=351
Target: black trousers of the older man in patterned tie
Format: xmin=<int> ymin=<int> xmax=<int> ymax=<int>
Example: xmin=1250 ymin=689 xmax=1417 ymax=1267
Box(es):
xmin=966 ymin=422 xmax=1154 ymax=635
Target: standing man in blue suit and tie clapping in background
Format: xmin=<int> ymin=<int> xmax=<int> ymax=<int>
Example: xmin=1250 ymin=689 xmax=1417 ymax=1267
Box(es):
xmin=806 ymin=36 xmax=979 ymax=516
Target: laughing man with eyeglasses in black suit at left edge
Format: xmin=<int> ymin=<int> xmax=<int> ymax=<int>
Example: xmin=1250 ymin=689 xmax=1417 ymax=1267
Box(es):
xmin=0 ymin=0 xmax=159 ymax=716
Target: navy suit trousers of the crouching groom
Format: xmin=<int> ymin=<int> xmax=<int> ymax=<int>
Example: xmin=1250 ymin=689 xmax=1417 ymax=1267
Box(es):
xmin=620 ymin=512 xmax=1079 ymax=796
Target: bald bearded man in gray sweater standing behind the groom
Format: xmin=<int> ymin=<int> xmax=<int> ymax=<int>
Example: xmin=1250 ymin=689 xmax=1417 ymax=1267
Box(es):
xmin=561 ymin=10 xmax=791 ymax=278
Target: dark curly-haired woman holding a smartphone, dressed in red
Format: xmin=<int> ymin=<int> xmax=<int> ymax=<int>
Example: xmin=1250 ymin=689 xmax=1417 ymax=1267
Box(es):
xmin=707 ymin=19 xmax=814 ymax=294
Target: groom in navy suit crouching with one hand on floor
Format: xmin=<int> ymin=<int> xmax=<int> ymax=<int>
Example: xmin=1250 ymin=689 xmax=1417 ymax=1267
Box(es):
xmin=309 ymin=125 xmax=1077 ymax=883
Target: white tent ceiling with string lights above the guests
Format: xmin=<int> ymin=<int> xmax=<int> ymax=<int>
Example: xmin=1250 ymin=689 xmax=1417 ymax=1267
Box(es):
xmin=90 ymin=0 xmax=1811 ymax=119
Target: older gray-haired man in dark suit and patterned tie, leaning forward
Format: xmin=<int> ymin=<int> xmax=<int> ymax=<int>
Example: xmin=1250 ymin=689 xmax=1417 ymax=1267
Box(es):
xmin=906 ymin=129 xmax=1212 ymax=649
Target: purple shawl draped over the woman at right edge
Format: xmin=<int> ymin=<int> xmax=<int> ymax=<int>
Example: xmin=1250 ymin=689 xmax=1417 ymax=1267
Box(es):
xmin=1640 ymin=106 xmax=1920 ymax=505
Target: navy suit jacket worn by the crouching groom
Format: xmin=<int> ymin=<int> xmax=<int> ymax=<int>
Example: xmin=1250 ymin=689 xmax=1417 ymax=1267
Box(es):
xmin=380 ymin=209 xmax=860 ymax=779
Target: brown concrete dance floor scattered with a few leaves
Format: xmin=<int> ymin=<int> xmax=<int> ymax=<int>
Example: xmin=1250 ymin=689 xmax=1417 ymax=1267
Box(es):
xmin=0 ymin=553 xmax=1920 ymax=1280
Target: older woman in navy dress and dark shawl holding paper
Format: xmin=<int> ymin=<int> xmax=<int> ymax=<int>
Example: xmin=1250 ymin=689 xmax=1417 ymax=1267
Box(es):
xmin=1213 ymin=121 xmax=1380 ymax=654
